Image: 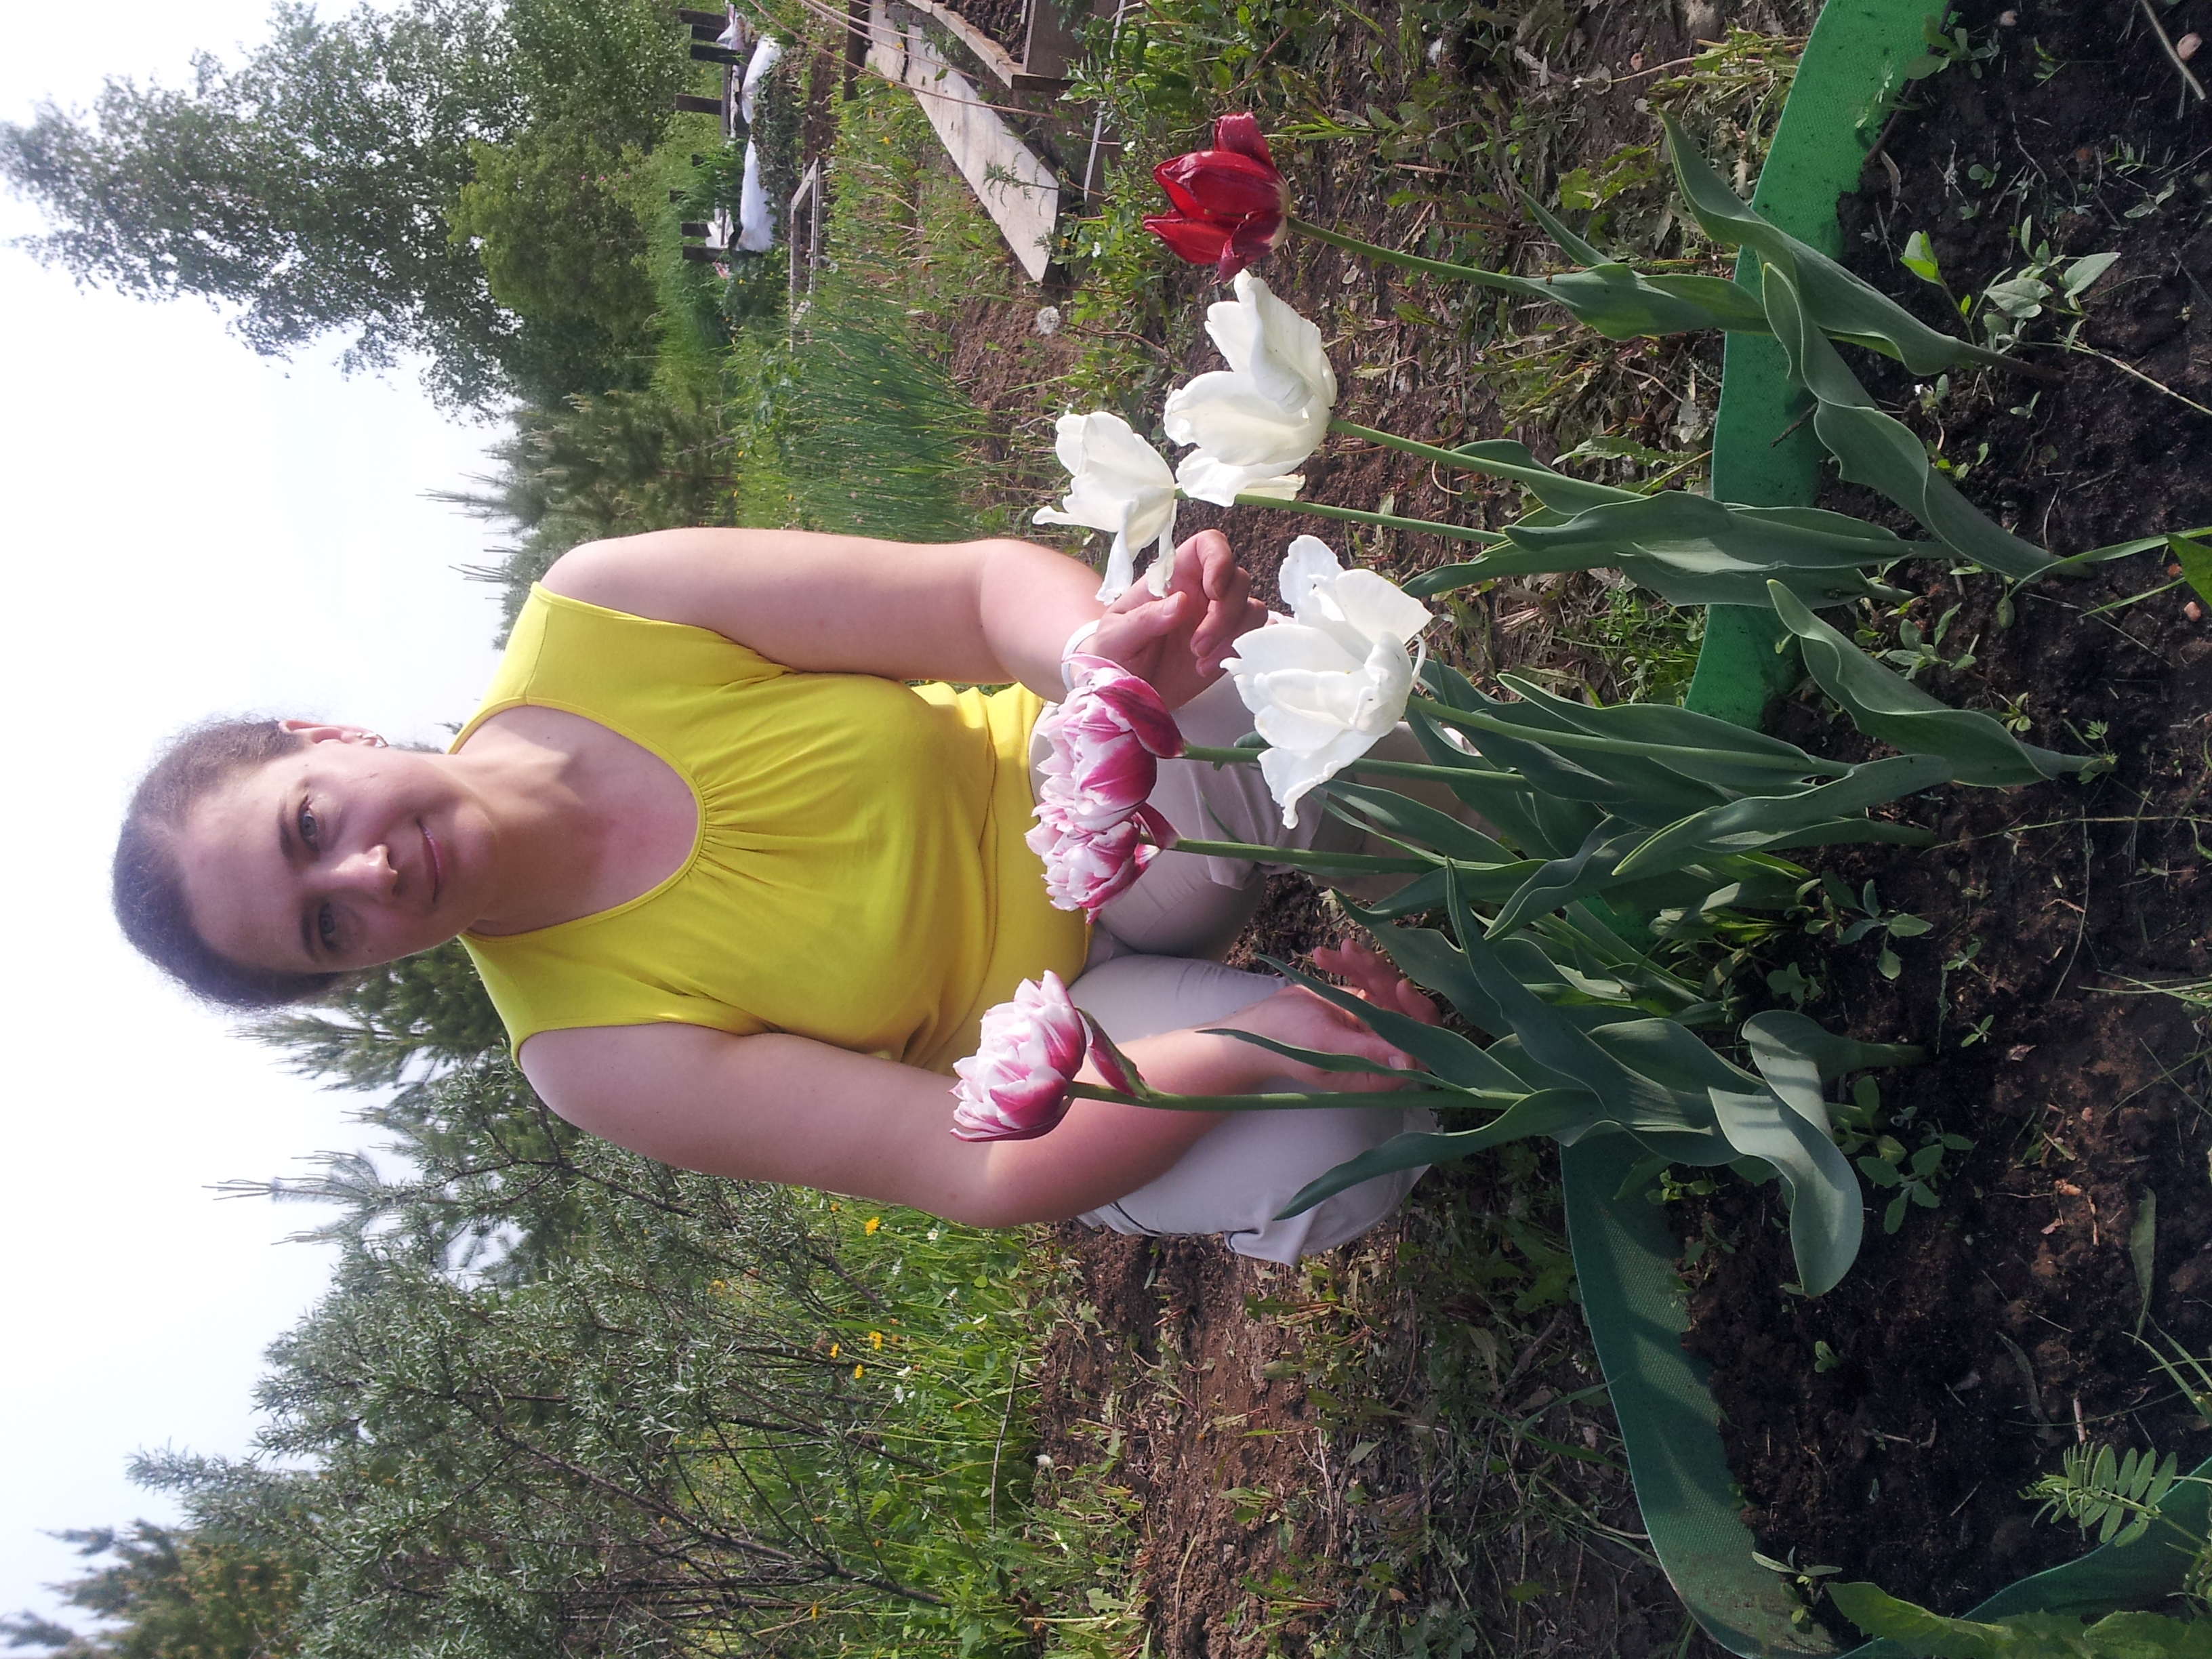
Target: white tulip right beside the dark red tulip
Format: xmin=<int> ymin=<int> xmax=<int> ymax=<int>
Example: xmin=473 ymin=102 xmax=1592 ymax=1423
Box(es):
xmin=1164 ymin=270 xmax=1336 ymax=506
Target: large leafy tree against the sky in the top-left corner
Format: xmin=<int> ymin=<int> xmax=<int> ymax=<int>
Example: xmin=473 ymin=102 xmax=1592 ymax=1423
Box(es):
xmin=0 ymin=0 xmax=686 ymax=407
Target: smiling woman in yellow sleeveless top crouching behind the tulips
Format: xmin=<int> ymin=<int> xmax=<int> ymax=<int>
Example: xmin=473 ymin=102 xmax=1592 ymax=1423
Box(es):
xmin=115 ymin=529 xmax=1427 ymax=1261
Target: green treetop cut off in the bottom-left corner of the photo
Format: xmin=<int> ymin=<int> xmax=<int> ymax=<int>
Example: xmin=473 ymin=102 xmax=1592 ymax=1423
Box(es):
xmin=0 ymin=1522 xmax=299 ymax=1659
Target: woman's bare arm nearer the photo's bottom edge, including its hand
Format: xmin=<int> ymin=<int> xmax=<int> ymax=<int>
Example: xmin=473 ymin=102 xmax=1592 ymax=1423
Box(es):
xmin=522 ymin=991 xmax=1409 ymax=1228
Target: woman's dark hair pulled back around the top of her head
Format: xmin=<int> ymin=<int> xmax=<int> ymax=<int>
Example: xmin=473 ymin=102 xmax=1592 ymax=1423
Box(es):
xmin=112 ymin=719 xmax=347 ymax=1008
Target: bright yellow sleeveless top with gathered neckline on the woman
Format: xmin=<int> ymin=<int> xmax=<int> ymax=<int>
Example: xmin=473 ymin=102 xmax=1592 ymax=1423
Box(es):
xmin=453 ymin=588 xmax=1088 ymax=1071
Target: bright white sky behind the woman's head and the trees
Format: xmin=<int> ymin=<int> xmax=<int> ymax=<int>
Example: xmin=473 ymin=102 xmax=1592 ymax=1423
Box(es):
xmin=0 ymin=0 xmax=497 ymax=1617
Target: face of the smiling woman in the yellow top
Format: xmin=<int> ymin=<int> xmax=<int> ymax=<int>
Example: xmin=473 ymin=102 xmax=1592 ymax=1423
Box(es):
xmin=177 ymin=723 xmax=493 ymax=973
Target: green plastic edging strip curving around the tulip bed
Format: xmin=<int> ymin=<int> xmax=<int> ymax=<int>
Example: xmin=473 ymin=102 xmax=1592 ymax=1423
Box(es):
xmin=1559 ymin=0 xmax=2212 ymax=1659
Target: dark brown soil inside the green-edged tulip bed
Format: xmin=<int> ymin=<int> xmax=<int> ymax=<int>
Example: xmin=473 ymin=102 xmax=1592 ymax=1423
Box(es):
xmin=1685 ymin=0 xmax=2212 ymax=1610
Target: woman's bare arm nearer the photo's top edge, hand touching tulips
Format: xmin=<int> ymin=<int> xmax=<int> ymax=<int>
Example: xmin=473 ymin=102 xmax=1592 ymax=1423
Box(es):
xmin=544 ymin=529 xmax=1263 ymax=703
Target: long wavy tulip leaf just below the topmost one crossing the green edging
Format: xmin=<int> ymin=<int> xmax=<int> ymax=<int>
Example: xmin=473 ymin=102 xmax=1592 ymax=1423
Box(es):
xmin=1761 ymin=255 xmax=2055 ymax=577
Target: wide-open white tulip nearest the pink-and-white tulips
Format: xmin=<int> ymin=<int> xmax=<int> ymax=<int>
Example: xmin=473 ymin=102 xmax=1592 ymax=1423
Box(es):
xmin=1223 ymin=535 xmax=1435 ymax=825
